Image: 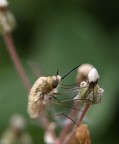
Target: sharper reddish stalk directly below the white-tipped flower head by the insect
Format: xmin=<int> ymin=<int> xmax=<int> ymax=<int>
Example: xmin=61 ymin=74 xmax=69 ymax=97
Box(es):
xmin=63 ymin=103 xmax=90 ymax=144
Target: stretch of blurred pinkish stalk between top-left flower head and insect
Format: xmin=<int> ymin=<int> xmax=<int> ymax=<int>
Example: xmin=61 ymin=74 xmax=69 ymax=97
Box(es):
xmin=3 ymin=33 xmax=31 ymax=91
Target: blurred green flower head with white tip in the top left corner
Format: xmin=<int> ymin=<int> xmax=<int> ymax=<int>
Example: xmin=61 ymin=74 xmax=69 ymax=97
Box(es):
xmin=0 ymin=0 xmax=16 ymax=33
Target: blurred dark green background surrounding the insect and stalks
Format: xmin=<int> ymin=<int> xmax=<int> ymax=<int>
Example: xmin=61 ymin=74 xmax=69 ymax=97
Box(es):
xmin=0 ymin=0 xmax=119 ymax=144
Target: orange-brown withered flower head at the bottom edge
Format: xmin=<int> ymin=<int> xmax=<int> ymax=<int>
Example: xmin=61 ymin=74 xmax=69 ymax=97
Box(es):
xmin=71 ymin=124 xmax=91 ymax=144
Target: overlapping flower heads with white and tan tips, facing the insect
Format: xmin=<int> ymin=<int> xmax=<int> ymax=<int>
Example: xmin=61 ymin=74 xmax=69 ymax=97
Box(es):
xmin=74 ymin=64 xmax=104 ymax=104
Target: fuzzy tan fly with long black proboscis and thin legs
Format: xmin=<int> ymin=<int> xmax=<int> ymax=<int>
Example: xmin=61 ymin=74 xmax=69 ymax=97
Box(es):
xmin=27 ymin=65 xmax=80 ymax=123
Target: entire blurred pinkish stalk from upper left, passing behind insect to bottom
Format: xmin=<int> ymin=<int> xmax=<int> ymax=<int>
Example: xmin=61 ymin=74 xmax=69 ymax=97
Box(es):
xmin=3 ymin=33 xmax=56 ymax=140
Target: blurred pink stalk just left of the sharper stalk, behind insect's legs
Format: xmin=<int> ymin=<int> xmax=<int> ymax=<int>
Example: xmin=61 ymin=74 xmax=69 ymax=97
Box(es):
xmin=59 ymin=101 xmax=80 ymax=144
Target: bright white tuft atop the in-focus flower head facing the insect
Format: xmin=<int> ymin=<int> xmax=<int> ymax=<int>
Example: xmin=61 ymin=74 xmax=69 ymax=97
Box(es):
xmin=88 ymin=68 xmax=99 ymax=83
